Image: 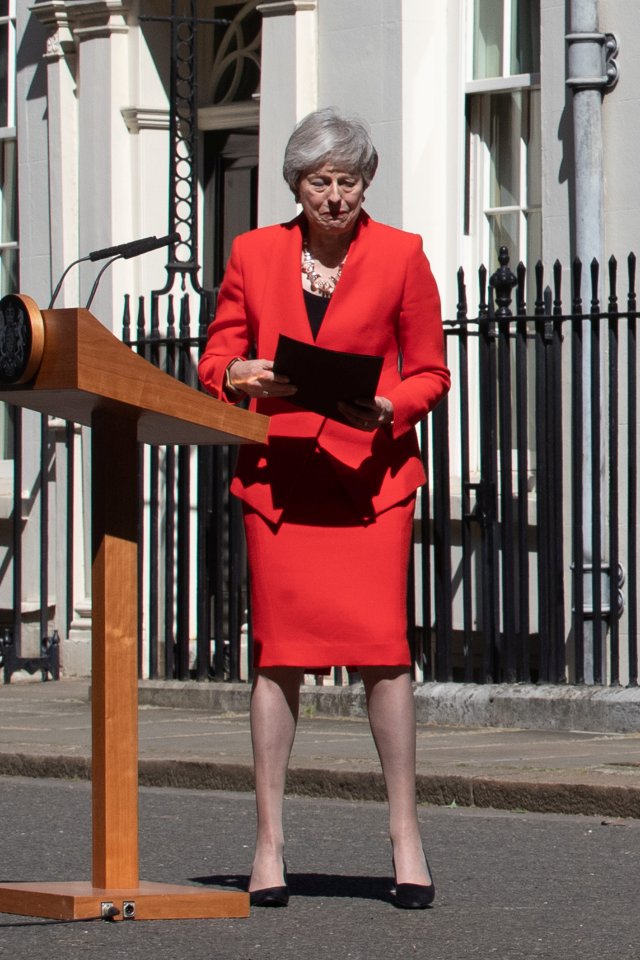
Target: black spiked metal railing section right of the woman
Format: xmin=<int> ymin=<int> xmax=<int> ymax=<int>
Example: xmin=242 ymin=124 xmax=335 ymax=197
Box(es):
xmin=421 ymin=248 xmax=638 ymax=685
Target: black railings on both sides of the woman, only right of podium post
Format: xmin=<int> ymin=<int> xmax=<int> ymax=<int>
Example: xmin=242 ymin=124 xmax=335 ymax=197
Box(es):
xmin=119 ymin=249 xmax=637 ymax=684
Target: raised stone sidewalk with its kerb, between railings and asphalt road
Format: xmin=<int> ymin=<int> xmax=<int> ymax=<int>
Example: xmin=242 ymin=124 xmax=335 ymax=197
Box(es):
xmin=0 ymin=680 xmax=640 ymax=819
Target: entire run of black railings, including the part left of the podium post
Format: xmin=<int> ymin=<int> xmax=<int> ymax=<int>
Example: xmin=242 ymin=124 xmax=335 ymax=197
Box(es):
xmin=0 ymin=249 xmax=638 ymax=685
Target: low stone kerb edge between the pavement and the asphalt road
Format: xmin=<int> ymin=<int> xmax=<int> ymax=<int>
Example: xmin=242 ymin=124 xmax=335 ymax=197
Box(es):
xmin=0 ymin=753 xmax=640 ymax=819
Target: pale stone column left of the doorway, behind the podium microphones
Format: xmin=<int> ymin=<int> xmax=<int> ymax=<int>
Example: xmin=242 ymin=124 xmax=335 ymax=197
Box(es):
xmin=29 ymin=0 xmax=132 ymax=675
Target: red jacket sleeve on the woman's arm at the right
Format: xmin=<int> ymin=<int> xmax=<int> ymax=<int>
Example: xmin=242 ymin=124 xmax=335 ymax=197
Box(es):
xmin=388 ymin=236 xmax=451 ymax=437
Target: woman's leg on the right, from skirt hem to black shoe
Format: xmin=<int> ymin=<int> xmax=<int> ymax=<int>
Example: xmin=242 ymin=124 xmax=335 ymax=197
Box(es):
xmin=360 ymin=667 xmax=430 ymax=884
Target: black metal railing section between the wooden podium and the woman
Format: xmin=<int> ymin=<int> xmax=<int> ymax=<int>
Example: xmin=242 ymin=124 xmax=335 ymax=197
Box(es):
xmin=123 ymin=292 xmax=250 ymax=680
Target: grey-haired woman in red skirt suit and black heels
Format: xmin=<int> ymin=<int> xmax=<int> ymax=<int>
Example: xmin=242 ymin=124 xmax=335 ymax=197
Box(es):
xmin=199 ymin=108 xmax=449 ymax=909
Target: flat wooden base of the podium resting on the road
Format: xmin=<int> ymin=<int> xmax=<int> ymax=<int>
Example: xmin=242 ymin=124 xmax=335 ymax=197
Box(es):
xmin=0 ymin=881 xmax=249 ymax=920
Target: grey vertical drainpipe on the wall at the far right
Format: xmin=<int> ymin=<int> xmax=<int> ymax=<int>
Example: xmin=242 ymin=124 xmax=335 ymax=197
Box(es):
xmin=566 ymin=0 xmax=618 ymax=683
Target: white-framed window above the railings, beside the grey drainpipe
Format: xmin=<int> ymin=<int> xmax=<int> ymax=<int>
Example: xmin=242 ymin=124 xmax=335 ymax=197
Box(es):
xmin=465 ymin=0 xmax=542 ymax=280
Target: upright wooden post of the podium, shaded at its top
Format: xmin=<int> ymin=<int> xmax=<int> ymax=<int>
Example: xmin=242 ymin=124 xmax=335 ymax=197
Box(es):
xmin=91 ymin=412 xmax=139 ymax=889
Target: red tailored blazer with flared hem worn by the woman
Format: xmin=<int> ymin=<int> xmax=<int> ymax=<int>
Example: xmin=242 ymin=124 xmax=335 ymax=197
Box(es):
xmin=199 ymin=213 xmax=450 ymax=522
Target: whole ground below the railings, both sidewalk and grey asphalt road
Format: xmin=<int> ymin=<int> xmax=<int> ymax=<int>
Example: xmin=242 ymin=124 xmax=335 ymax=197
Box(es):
xmin=0 ymin=680 xmax=640 ymax=960
